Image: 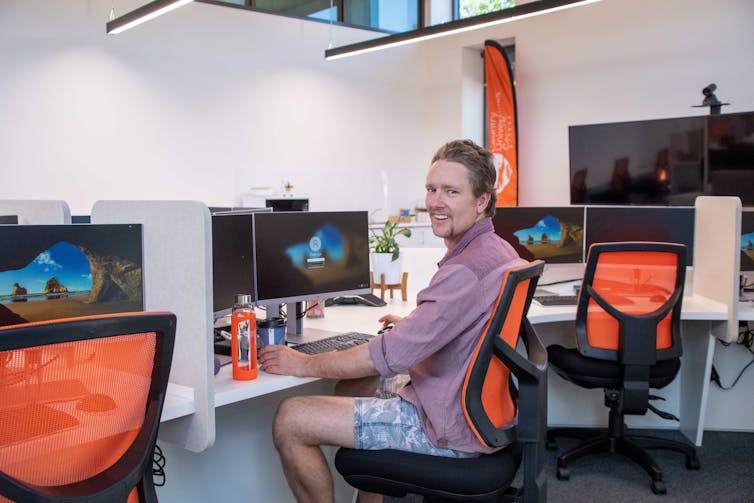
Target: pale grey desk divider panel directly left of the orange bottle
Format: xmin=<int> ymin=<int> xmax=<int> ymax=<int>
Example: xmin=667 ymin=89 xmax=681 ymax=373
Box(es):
xmin=92 ymin=201 xmax=215 ymax=452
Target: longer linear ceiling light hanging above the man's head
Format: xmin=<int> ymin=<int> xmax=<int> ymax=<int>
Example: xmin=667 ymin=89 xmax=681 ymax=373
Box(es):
xmin=325 ymin=0 xmax=600 ymax=60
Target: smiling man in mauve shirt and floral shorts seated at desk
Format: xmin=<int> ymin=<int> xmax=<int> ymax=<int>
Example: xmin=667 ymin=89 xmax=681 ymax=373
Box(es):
xmin=260 ymin=140 xmax=524 ymax=502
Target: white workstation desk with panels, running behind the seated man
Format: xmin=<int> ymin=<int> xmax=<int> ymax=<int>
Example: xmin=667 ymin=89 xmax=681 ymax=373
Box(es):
xmin=158 ymin=295 xmax=727 ymax=503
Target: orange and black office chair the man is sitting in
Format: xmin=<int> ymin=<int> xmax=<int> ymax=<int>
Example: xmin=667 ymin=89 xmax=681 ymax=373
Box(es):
xmin=335 ymin=261 xmax=547 ymax=502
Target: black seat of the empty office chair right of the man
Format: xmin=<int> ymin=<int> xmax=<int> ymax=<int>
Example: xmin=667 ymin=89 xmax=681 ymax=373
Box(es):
xmin=547 ymin=344 xmax=681 ymax=389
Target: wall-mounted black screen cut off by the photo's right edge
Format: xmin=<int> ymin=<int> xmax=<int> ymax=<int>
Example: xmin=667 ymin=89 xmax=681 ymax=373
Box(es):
xmin=707 ymin=112 xmax=754 ymax=205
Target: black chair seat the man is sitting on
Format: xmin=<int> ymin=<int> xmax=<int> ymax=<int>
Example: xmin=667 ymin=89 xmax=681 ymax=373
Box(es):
xmin=335 ymin=443 xmax=521 ymax=501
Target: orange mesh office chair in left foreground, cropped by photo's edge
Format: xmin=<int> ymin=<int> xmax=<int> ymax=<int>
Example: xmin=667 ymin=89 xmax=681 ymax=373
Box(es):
xmin=0 ymin=314 xmax=176 ymax=503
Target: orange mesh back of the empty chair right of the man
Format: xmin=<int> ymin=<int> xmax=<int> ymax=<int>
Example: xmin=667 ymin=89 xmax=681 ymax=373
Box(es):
xmin=576 ymin=242 xmax=686 ymax=365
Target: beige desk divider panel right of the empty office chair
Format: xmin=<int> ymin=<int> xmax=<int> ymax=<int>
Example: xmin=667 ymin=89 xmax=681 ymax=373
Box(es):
xmin=693 ymin=196 xmax=741 ymax=342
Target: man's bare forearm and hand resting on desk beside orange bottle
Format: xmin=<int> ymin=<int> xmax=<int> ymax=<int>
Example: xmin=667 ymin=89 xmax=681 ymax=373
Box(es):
xmin=259 ymin=344 xmax=378 ymax=379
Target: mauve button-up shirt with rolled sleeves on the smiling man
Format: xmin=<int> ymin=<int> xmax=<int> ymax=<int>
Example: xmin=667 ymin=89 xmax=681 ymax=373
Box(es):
xmin=368 ymin=218 xmax=526 ymax=452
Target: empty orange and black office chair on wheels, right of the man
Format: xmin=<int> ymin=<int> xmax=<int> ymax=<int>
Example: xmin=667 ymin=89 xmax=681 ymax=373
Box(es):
xmin=547 ymin=242 xmax=699 ymax=494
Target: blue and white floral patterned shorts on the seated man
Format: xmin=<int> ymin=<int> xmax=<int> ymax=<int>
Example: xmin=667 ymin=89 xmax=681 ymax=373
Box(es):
xmin=353 ymin=375 xmax=479 ymax=458
